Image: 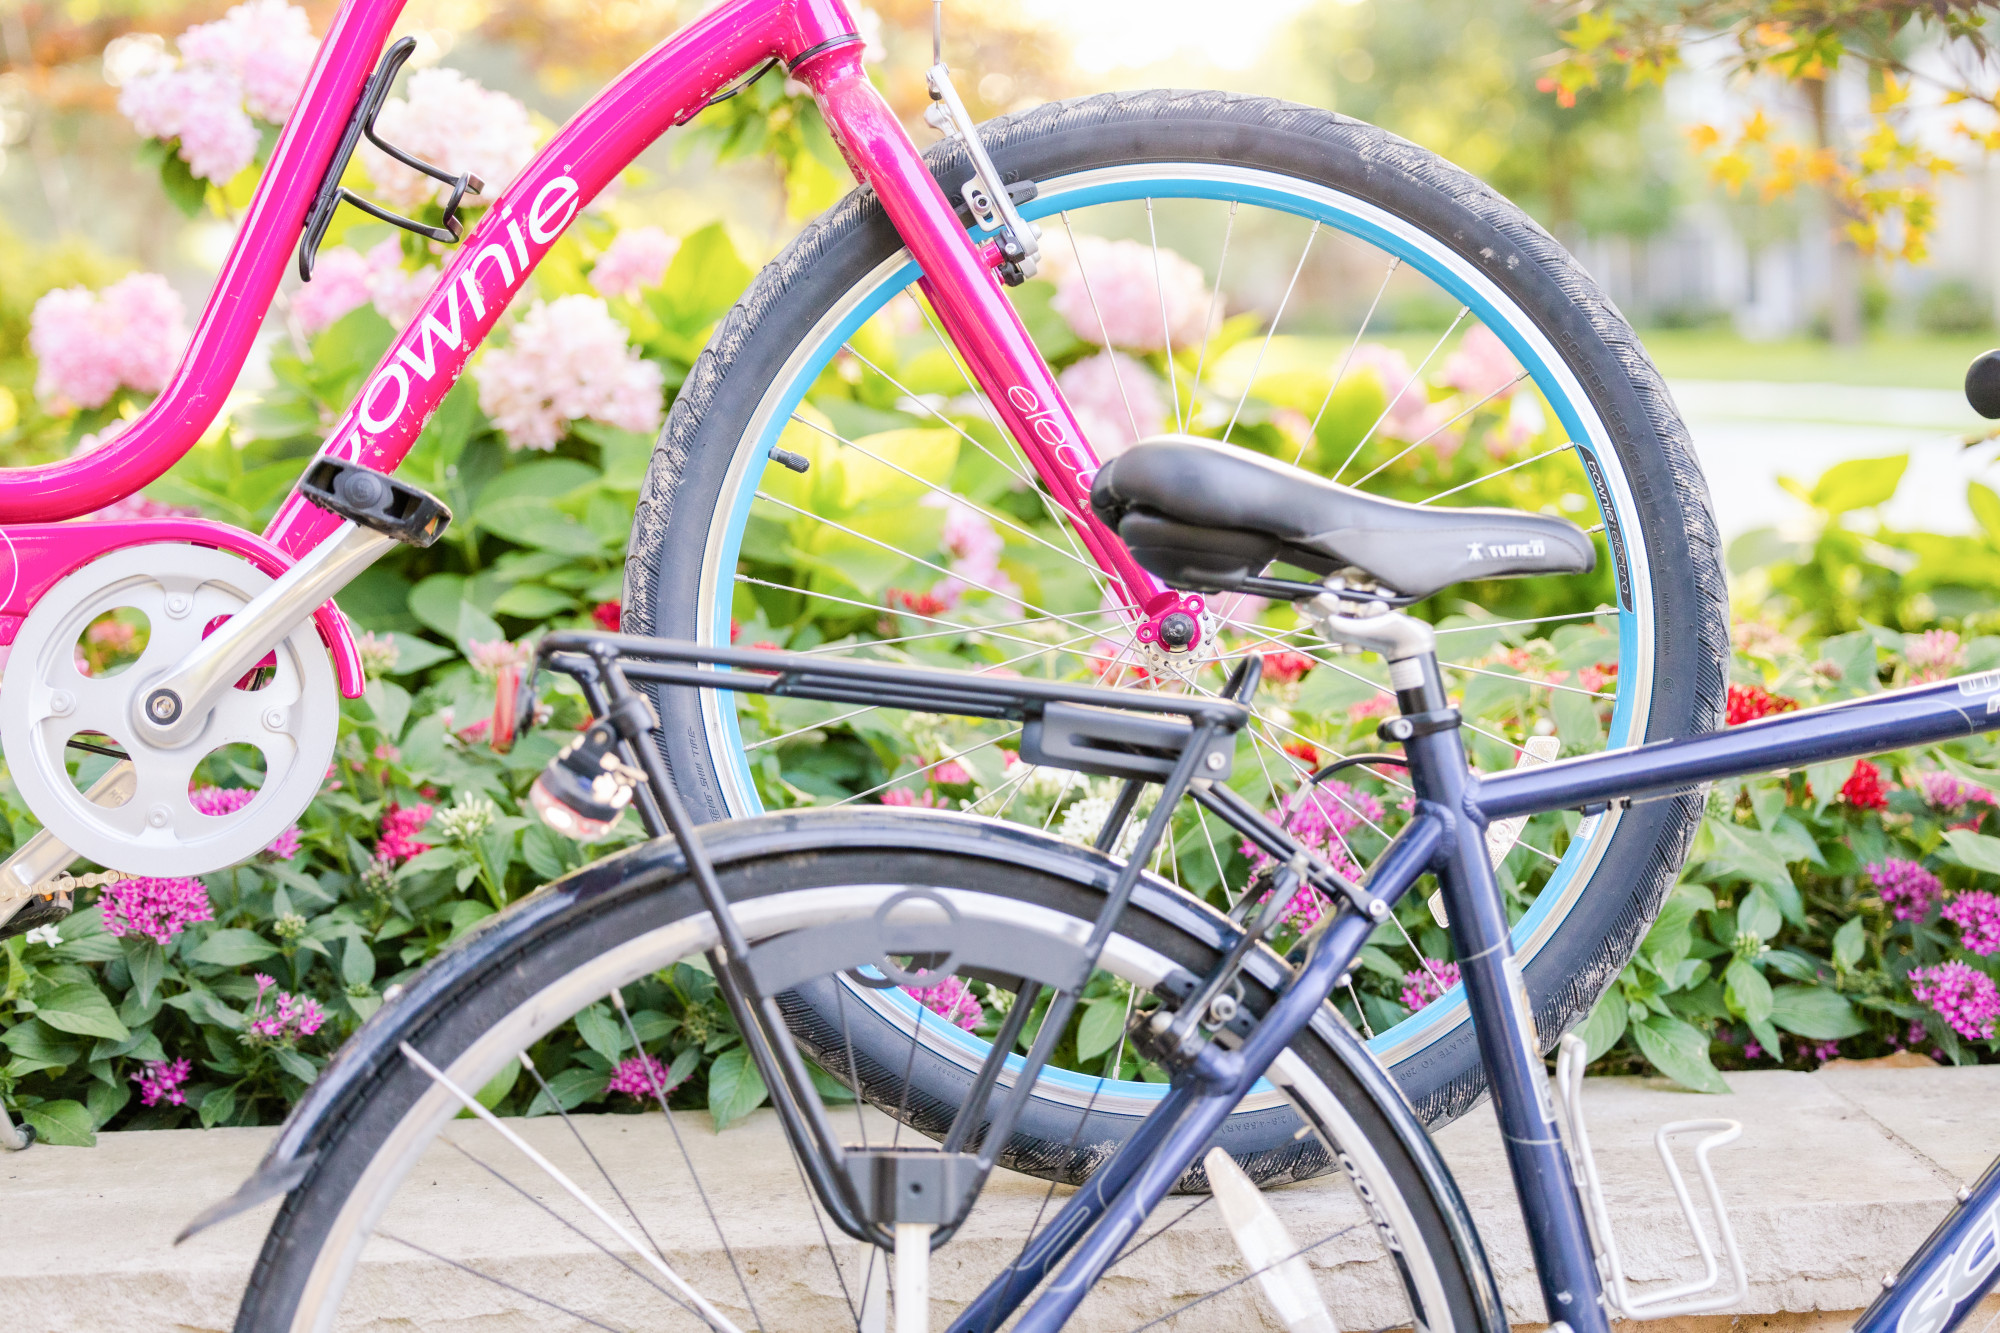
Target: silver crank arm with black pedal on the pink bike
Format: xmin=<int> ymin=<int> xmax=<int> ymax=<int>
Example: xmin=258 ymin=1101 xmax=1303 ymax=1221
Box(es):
xmin=132 ymin=456 xmax=452 ymax=751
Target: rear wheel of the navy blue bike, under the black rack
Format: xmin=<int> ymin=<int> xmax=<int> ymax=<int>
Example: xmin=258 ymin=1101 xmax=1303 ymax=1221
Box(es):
xmin=236 ymin=811 xmax=1502 ymax=1333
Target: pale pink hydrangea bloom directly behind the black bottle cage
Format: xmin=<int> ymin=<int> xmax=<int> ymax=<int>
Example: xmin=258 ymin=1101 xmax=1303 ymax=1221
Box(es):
xmin=368 ymin=68 xmax=534 ymax=208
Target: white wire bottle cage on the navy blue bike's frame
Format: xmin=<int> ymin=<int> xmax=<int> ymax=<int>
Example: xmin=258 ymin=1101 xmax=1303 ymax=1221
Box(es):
xmin=1556 ymin=1020 xmax=1750 ymax=1319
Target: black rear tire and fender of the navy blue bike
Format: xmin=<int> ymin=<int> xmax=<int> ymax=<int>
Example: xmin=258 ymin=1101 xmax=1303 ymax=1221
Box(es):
xmin=236 ymin=811 xmax=1504 ymax=1333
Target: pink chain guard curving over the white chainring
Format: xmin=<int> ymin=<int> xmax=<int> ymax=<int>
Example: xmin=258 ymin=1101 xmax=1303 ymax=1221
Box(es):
xmin=0 ymin=518 xmax=368 ymax=699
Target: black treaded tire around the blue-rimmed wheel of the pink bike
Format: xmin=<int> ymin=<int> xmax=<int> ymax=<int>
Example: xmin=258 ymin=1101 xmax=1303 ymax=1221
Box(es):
xmin=624 ymin=92 xmax=1728 ymax=1125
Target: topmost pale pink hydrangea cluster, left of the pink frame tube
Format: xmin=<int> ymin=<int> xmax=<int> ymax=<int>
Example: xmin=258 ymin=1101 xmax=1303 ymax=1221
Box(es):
xmin=118 ymin=0 xmax=320 ymax=184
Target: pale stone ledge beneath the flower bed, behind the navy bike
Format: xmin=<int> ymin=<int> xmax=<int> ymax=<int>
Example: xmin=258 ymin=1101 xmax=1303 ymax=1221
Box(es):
xmin=0 ymin=1067 xmax=2000 ymax=1333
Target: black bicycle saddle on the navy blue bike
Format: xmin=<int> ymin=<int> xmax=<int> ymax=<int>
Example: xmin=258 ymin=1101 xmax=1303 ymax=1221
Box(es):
xmin=1090 ymin=434 xmax=1596 ymax=598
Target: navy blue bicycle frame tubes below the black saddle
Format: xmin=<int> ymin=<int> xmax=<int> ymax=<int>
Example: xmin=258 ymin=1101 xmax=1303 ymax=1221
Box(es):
xmin=980 ymin=658 xmax=2000 ymax=1333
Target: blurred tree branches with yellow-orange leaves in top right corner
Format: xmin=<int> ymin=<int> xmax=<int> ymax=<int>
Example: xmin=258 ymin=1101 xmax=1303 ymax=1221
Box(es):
xmin=1544 ymin=0 xmax=2000 ymax=340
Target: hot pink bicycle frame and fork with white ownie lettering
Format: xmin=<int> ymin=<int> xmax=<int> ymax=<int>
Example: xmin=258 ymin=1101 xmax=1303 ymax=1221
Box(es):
xmin=0 ymin=0 xmax=1178 ymax=697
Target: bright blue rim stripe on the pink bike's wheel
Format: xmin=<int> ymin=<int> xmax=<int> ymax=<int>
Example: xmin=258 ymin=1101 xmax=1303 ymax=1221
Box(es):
xmin=710 ymin=172 xmax=1648 ymax=1099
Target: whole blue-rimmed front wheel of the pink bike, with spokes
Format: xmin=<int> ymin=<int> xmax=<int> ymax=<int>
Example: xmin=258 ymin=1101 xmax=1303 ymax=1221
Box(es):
xmin=624 ymin=92 xmax=1728 ymax=1133
